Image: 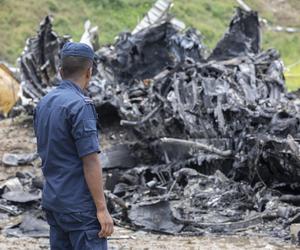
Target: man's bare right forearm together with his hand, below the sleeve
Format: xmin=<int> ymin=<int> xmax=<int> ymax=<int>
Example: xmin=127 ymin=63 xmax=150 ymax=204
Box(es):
xmin=82 ymin=153 xmax=114 ymax=237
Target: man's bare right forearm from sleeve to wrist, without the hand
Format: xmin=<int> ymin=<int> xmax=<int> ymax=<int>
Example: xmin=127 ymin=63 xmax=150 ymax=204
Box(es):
xmin=83 ymin=153 xmax=106 ymax=211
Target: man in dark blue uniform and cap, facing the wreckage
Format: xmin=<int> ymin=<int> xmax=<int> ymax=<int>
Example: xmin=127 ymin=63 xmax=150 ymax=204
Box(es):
xmin=34 ymin=43 xmax=113 ymax=250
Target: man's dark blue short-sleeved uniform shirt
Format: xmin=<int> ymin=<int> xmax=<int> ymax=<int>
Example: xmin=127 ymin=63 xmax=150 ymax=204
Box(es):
xmin=34 ymin=80 xmax=100 ymax=213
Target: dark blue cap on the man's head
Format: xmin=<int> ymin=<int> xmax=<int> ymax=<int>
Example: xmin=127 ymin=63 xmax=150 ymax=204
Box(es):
xmin=60 ymin=42 xmax=95 ymax=61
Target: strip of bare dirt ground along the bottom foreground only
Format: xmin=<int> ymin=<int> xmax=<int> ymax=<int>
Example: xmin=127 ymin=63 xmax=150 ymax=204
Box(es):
xmin=0 ymin=227 xmax=300 ymax=250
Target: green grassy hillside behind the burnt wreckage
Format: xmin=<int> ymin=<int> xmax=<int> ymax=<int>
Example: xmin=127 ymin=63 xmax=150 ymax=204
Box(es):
xmin=0 ymin=0 xmax=300 ymax=89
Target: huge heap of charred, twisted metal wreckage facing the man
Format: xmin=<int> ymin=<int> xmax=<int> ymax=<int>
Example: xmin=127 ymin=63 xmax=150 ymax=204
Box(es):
xmin=0 ymin=1 xmax=300 ymax=242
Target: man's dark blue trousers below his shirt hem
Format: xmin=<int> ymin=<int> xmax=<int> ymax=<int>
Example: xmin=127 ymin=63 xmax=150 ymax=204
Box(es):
xmin=45 ymin=210 xmax=107 ymax=250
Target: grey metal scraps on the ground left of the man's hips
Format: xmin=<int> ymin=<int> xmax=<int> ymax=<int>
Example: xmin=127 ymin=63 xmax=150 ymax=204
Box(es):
xmin=0 ymin=172 xmax=44 ymax=237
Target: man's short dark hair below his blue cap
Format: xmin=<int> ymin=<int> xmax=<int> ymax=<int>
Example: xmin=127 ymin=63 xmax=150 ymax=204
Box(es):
xmin=61 ymin=56 xmax=93 ymax=78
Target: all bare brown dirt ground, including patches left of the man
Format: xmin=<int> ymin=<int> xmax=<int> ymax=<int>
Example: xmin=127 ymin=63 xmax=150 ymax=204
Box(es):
xmin=0 ymin=117 xmax=300 ymax=250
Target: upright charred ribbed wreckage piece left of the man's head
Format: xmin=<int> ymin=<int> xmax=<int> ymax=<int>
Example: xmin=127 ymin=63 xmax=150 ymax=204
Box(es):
xmin=20 ymin=16 xmax=69 ymax=99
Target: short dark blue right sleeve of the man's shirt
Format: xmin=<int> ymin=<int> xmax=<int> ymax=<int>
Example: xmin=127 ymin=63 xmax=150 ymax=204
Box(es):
xmin=71 ymin=103 xmax=100 ymax=158
